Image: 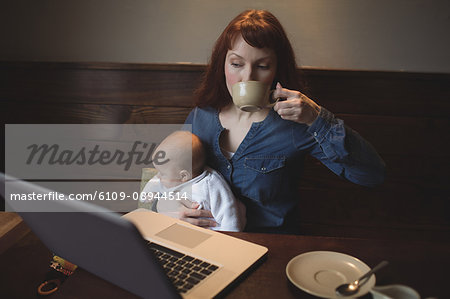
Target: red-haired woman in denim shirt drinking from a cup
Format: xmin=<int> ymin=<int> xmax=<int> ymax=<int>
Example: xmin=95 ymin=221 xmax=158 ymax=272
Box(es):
xmin=180 ymin=10 xmax=384 ymax=231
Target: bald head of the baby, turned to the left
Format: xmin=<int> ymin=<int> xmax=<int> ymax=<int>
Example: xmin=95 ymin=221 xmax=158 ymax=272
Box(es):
xmin=155 ymin=131 xmax=205 ymax=188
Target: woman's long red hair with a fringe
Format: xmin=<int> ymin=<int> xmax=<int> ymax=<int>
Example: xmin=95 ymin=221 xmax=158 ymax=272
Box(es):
xmin=195 ymin=10 xmax=302 ymax=109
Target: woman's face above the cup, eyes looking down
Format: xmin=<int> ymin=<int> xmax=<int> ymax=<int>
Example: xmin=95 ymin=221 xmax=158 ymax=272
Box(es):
xmin=225 ymin=36 xmax=277 ymax=95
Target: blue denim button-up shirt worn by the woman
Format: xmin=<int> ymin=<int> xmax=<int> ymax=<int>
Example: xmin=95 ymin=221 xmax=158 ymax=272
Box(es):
xmin=185 ymin=107 xmax=384 ymax=229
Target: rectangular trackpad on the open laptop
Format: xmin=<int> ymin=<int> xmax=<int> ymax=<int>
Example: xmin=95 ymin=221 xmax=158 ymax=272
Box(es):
xmin=156 ymin=223 xmax=211 ymax=248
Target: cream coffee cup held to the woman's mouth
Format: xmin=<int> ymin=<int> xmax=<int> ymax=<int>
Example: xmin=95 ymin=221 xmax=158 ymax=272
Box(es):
xmin=231 ymin=81 xmax=279 ymax=112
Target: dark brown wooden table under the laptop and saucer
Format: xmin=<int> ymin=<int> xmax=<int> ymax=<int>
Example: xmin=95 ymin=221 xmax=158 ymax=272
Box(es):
xmin=0 ymin=232 xmax=450 ymax=299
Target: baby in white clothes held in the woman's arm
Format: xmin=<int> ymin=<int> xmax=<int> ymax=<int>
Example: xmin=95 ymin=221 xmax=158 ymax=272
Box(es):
xmin=142 ymin=131 xmax=246 ymax=231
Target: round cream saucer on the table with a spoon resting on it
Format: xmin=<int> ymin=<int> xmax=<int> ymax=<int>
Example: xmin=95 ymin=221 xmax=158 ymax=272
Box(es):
xmin=286 ymin=251 xmax=375 ymax=298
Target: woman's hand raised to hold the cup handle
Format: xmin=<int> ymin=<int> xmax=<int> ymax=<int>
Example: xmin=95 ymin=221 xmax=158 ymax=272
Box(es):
xmin=273 ymin=83 xmax=320 ymax=126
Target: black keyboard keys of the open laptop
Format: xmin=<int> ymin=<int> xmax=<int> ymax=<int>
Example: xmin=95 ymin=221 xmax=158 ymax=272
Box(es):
xmin=147 ymin=242 xmax=219 ymax=293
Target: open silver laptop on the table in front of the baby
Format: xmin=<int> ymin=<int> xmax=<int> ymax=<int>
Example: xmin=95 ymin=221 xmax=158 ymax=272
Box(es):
xmin=0 ymin=173 xmax=268 ymax=298
